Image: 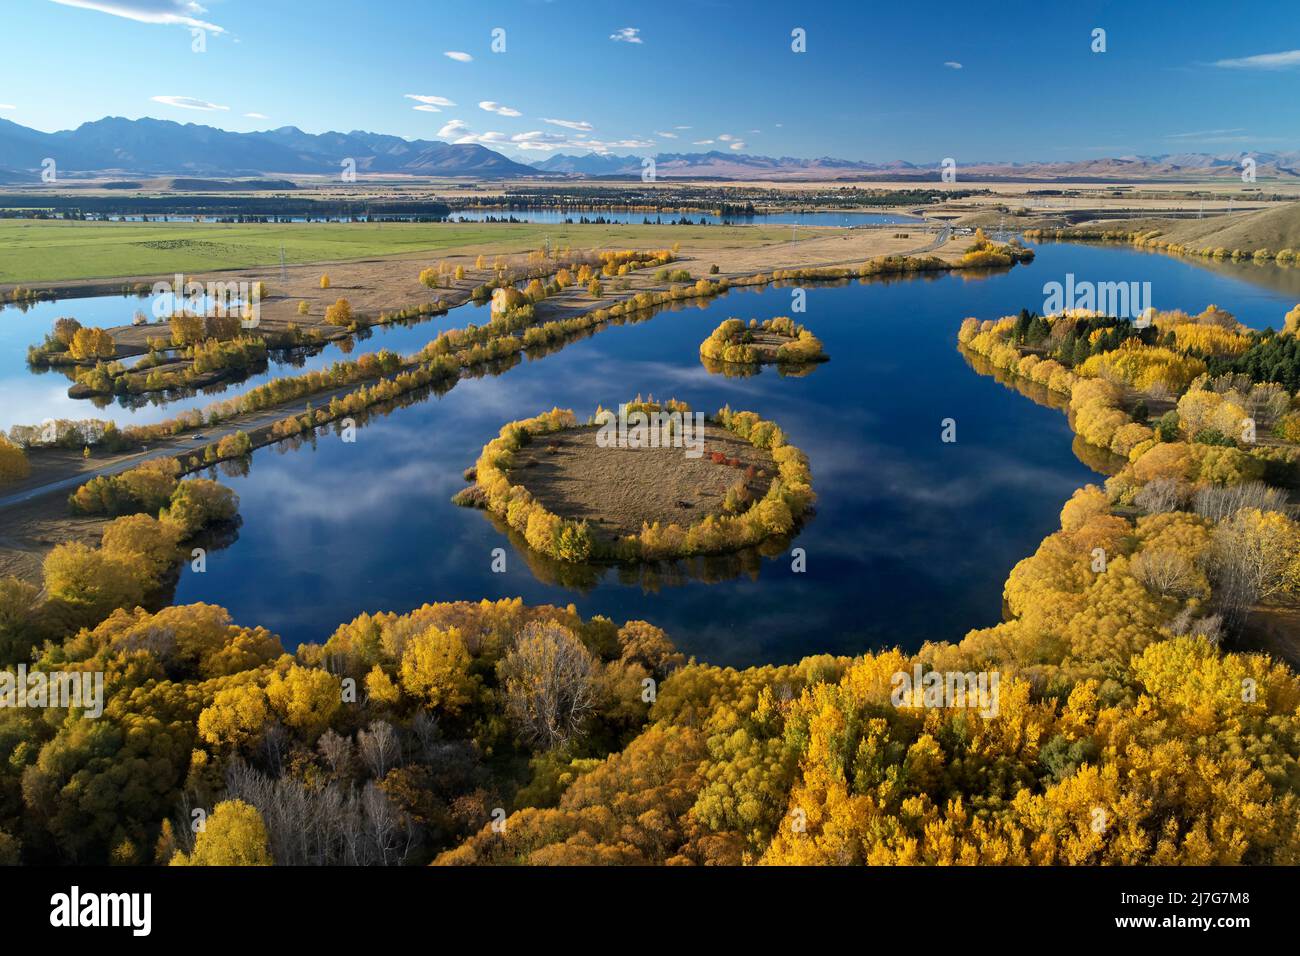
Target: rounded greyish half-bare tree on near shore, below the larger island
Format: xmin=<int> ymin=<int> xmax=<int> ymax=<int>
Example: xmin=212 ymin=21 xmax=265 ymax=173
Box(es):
xmin=499 ymin=622 xmax=595 ymax=748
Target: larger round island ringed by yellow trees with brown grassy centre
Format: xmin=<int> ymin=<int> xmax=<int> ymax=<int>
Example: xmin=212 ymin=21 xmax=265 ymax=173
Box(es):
xmin=452 ymin=397 xmax=815 ymax=562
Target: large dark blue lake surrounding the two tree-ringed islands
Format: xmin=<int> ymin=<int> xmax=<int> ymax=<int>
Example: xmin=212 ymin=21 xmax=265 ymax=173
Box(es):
xmin=116 ymin=245 xmax=1300 ymax=666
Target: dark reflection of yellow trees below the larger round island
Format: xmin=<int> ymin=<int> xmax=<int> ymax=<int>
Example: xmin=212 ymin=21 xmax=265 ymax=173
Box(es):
xmin=478 ymin=509 xmax=811 ymax=594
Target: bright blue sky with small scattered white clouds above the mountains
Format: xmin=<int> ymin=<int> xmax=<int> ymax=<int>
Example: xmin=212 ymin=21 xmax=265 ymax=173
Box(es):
xmin=0 ymin=0 xmax=1300 ymax=163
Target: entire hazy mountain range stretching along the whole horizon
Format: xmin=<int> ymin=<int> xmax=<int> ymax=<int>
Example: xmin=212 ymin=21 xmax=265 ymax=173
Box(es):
xmin=0 ymin=117 xmax=1300 ymax=185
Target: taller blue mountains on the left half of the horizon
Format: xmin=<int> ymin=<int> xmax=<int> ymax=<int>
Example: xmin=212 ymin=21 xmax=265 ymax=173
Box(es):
xmin=0 ymin=117 xmax=538 ymax=178
